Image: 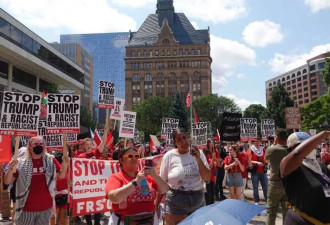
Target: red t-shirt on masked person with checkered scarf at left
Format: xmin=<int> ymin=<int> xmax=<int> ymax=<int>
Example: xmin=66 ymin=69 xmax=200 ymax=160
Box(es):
xmin=23 ymin=158 xmax=61 ymax=212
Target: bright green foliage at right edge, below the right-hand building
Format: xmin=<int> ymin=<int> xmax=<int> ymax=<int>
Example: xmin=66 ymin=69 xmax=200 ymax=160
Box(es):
xmin=300 ymin=94 xmax=330 ymax=132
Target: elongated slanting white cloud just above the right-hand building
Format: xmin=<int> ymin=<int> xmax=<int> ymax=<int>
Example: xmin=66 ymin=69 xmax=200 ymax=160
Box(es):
xmin=268 ymin=44 xmax=330 ymax=74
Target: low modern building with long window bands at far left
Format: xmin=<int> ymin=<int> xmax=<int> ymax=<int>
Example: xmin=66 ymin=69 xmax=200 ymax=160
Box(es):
xmin=0 ymin=9 xmax=84 ymax=94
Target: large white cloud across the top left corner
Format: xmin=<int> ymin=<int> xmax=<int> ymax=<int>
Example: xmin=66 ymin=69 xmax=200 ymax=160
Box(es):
xmin=2 ymin=0 xmax=136 ymax=33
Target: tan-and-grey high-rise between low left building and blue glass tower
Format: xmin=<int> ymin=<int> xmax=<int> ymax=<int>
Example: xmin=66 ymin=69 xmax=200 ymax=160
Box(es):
xmin=51 ymin=43 xmax=93 ymax=112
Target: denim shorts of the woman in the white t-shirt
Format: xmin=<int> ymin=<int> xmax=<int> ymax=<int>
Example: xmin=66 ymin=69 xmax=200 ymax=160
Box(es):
xmin=165 ymin=189 xmax=205 ymax=215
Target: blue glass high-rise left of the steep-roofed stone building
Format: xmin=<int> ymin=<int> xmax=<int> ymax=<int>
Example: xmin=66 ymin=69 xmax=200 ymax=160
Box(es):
xmin=60 ymin=32 xmax=129 ymax=123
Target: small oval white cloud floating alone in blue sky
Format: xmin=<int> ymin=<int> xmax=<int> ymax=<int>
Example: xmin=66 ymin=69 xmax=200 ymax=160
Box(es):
xmin=242 ymin=20 xmax=283 ymax=47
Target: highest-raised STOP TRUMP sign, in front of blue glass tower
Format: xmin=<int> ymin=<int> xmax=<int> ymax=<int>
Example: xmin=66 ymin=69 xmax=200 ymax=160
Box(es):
xmin=98 ymin=80 xmax=115 ymax=109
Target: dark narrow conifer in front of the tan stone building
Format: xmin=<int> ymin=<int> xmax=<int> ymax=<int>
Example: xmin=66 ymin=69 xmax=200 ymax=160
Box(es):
xmin=168 ymin=92 xmax=190 ymax=132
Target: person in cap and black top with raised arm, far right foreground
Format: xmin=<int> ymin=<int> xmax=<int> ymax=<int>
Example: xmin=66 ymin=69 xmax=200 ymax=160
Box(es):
xmin=280 ymin=131 xmax=330 ymax=225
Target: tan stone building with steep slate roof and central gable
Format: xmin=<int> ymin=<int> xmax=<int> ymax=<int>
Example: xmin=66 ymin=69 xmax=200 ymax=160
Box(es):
xmin=125 ymin=0 xmax=212 ymax=109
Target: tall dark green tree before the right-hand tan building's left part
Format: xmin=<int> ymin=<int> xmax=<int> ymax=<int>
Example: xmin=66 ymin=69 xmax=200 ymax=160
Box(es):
xmin=264 ymin=83 xmax=294 ymax=128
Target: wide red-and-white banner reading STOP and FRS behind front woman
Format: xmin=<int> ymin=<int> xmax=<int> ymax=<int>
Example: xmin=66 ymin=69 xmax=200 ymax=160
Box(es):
xmin=72 ymin=155 xmax=163 ymax=216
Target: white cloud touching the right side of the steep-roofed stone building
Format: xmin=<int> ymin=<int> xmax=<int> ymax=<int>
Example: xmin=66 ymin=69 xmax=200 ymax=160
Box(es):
xmin=211 ymin=35 xmax=256 ymax=92
